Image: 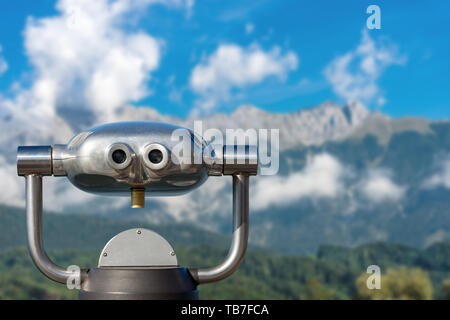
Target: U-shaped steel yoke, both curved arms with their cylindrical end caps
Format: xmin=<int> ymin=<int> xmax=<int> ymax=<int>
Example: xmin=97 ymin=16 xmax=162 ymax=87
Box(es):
xmin=21 ymin=146 xmax=257 ymax=284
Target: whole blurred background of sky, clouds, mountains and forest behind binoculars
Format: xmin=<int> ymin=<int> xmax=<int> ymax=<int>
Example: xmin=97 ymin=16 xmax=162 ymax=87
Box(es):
xmin=0 ymin=0 xmax=450 ymax=299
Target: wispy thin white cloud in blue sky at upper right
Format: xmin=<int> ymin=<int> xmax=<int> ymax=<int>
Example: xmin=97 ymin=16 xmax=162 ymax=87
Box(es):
xmin=324 ymin=30 xmax=406 ymax=105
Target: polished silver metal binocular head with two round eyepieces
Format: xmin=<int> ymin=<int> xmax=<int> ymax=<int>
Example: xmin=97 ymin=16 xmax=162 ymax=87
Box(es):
xmin=54 ymin=122 xmax=208 ymax=196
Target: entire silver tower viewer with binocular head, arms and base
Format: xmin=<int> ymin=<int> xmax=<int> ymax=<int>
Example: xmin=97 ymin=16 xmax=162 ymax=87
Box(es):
xmin=17 ymin=122 xmax=258 ymax=299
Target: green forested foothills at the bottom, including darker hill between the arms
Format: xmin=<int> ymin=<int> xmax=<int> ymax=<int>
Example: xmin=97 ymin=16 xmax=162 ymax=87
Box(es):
xmin=0 ymin=195 xmax=450 ymax=299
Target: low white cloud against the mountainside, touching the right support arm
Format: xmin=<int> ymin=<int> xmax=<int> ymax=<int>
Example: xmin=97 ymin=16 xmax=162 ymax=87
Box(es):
xmin=251 ymin=153 xmax=348 ymax=210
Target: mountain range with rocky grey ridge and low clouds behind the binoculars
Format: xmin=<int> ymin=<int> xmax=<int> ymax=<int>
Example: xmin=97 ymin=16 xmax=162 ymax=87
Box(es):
xmin=0 ymin=101 xmax=450 ymax=254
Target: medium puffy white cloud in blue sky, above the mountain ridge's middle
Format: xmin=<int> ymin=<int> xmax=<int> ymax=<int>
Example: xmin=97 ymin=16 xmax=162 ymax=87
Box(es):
xmin=190 ymin=44 xmax=298 ymax=111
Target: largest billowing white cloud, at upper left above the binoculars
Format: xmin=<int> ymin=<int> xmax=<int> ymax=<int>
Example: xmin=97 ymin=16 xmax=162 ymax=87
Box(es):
xmin=0 ymin=0 xmax=193 ymax=121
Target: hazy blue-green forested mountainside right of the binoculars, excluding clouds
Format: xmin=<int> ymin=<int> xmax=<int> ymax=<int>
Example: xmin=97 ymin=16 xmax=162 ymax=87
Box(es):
xmin=252 ymin=122 xmax=450 ymax=254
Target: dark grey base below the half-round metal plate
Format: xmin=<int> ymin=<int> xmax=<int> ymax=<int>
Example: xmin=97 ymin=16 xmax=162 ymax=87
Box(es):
xmin=78 ymin=267 xmax=198 ymax=300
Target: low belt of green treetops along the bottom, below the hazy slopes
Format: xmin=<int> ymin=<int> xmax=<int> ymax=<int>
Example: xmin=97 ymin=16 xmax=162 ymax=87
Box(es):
xmin=0 ymin=243 xmax=450 ymax=299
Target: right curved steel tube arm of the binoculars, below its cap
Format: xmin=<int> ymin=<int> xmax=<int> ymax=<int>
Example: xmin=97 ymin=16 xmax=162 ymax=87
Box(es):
xmin=189 ymin=174 xmax=249 ymax=284
